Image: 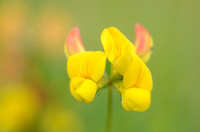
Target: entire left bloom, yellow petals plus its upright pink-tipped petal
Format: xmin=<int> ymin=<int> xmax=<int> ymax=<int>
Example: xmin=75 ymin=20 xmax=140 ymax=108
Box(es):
xmin=65 ymin=28 xmax=106 ymax=104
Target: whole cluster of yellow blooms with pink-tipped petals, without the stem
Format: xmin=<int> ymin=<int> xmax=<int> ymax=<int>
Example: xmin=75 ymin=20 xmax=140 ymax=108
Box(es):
xmin=65 ymin=25 xmax=153 ymax=111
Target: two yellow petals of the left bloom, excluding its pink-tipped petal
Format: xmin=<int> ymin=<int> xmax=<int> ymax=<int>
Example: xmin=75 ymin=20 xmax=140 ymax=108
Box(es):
xmin=67 ymin=51 xmax=106 ymax=104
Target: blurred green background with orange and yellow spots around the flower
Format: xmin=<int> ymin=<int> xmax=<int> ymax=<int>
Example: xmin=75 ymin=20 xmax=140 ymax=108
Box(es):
xmin=0 ymin=0 xmax=200 ymax=132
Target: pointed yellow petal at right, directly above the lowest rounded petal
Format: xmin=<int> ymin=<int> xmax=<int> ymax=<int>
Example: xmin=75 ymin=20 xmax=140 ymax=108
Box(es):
xmin=123 ymin=54 xmax=153 ymax=91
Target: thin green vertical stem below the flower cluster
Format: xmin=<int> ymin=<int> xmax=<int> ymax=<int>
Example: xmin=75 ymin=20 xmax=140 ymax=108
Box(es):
xmin=107 ymin=87 xmax=112 ymax=132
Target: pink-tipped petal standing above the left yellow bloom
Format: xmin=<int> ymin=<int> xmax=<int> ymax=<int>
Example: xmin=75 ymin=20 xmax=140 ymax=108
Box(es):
xmin=64 ymin=27 xmax=85 ymax=57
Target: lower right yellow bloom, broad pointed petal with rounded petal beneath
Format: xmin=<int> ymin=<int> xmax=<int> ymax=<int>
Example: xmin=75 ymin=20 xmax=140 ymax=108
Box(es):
xmin=120 ymin=54 xmax=153 ymax=111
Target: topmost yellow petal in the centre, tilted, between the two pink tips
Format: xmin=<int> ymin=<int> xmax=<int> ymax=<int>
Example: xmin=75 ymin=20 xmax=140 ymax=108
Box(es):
xmin=101 ymin=27 xmax=135 ymax=74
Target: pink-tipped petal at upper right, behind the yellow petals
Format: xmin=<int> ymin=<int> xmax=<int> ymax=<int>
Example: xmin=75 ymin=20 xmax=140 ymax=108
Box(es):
xmin=135 ymin=24 xmax=153 ymax=62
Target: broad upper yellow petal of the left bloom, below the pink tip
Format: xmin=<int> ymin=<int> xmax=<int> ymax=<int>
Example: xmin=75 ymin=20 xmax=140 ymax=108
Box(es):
xmin=67 ymin=51 xmax=106 ymax=82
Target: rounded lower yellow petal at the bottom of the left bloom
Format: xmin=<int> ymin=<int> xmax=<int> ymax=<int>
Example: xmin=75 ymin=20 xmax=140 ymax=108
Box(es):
xmin=70 ymin=77 xmax=97 ymax=104
